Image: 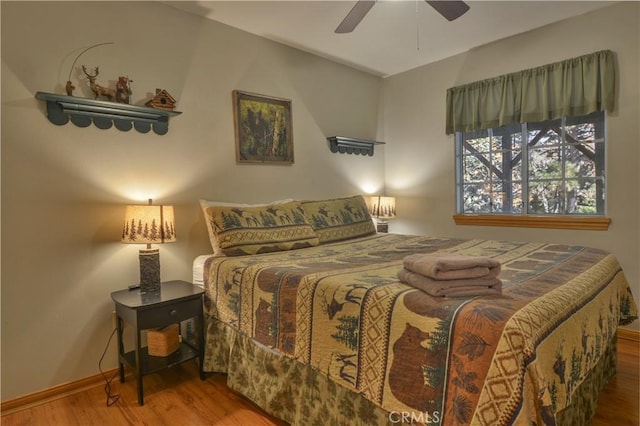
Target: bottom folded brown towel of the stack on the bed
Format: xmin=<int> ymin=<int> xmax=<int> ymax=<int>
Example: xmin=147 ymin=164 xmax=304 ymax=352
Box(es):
xmin=398 ymin=269 xmax=502 ymax=297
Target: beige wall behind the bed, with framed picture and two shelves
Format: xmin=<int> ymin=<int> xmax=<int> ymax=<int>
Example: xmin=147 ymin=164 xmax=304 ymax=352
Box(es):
xmin=1 ymin=1 xmax=384 ymax=400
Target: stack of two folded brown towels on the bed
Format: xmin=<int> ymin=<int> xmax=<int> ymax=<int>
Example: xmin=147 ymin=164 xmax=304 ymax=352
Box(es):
xmin=398 ymin=253 xmax=502 ymax=297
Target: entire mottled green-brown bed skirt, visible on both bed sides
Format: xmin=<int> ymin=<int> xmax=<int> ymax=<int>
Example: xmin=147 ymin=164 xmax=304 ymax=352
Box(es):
xmin=204 ymin=317 xmax=616 ymax=426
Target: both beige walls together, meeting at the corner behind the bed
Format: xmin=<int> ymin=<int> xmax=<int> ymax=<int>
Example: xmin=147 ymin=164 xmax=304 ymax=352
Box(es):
xmin=1 ymin=1 xmax=640 ymax=401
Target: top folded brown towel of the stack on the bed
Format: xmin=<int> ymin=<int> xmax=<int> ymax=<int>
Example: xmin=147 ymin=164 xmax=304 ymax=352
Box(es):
xmin=403 ymin=253 xmax=500 ymax=280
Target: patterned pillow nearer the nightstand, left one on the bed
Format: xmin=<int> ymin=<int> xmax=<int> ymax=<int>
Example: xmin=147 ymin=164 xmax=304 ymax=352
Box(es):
xmin=204 ymin=201 xmax=319 ymax=256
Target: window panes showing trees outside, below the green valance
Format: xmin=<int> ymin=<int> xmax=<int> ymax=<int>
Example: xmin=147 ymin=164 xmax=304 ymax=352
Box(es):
xmin=456 ymin=112 xmax=605 ymax=215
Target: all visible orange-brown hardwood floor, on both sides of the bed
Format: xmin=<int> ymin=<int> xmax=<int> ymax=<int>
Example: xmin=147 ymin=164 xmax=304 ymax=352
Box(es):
xmin=1 ymin=339 xmax=640 ymax=426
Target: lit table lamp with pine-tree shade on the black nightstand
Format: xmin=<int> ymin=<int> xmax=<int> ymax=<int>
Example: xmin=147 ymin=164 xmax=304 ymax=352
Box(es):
xmin=121 ymin=199 xmax=176 ymax=293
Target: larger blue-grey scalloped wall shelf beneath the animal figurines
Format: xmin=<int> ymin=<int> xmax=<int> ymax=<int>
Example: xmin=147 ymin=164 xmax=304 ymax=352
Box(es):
xmin=36 ymin=92 xmax=182 ymax=135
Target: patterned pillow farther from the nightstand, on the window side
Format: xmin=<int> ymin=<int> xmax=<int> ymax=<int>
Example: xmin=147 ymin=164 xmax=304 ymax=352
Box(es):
xmin=302 ymin=195 xmax=376 ymax=244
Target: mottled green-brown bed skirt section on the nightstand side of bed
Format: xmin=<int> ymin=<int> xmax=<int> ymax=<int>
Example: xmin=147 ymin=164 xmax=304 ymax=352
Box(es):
xmin=204 ymin=318 xmax=393 ymax=425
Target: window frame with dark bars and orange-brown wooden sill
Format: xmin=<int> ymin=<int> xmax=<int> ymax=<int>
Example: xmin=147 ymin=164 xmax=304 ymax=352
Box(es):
xmin=453 ymin=111 xmax=611 ymax=230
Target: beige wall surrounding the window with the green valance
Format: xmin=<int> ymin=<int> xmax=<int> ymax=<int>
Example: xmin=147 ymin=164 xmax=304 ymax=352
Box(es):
xmin=380 ymin=2 xmax=640 ymax=329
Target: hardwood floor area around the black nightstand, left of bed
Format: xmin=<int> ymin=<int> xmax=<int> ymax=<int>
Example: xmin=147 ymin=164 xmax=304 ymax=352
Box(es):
xmin=0 ymin=362 xmax=286 ymax=426
